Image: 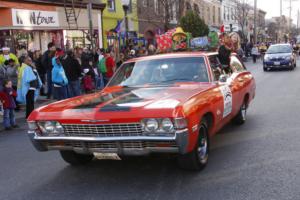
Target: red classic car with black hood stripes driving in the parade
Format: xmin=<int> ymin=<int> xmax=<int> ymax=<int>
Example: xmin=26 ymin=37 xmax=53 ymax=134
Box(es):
xmin=28 ymin=52 xmax=256 ymax=170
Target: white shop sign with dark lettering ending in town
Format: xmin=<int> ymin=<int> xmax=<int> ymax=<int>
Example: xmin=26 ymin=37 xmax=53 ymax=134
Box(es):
xmin=12 ymin=9 xmax=59 ymax=27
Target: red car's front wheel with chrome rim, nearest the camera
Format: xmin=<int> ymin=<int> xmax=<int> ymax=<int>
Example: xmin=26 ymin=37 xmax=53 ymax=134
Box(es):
xmin=178 ymin=120 xmax=209 ymax=171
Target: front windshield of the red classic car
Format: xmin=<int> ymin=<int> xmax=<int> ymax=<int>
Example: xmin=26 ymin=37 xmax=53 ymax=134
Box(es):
xmin=109 ymin=57 xmax=208 ymax=87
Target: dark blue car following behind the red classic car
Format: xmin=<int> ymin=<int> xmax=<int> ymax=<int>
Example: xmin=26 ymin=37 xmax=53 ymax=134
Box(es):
xmin=263 ymin=44 xmax=297 ymax=71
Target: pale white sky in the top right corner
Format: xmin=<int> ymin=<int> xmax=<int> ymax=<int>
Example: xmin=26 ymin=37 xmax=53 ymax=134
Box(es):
xmin=258 ymin=0 xmax=300 ymax=24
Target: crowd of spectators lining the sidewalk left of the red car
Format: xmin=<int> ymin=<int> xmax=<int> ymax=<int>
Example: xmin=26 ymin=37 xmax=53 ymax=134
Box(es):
xmin=0 ymin=43 xmax=156 ymax=130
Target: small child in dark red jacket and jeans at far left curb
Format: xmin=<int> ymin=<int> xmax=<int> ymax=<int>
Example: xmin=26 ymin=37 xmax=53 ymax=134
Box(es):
xmin=0 ymin=80 xmax=18 ymax=130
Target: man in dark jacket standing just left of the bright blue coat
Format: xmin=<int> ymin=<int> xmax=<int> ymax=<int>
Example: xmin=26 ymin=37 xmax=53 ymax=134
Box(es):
xmin=42 ymin=42 xmax=56 ymax=99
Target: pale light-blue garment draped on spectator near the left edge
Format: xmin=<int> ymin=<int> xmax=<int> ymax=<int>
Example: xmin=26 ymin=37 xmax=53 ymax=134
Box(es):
xmin=17 ymin=65 xmax=42 ymax=104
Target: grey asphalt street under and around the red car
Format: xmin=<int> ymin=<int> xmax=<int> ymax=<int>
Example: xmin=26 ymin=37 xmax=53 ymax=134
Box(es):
xmin=0 ymin=60 xmax=300 ymax=200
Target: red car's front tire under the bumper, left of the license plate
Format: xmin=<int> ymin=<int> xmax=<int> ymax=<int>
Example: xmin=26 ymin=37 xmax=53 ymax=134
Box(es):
xmin=60 ymin=151 xmax=94 ymax=166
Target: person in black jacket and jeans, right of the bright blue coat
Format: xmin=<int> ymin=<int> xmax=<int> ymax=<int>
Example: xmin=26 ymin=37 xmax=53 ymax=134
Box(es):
xmin=62 ymin=50 xmax=82 ymax=97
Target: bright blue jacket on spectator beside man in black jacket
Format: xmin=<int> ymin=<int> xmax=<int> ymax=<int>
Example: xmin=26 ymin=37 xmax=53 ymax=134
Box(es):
xmin=52 ymin=57 xmax=68 ymax=86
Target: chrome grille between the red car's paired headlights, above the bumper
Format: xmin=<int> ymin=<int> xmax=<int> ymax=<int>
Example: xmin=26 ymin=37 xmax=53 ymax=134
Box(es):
xmin=63 ymin=123 xmax=143 ymax=137
